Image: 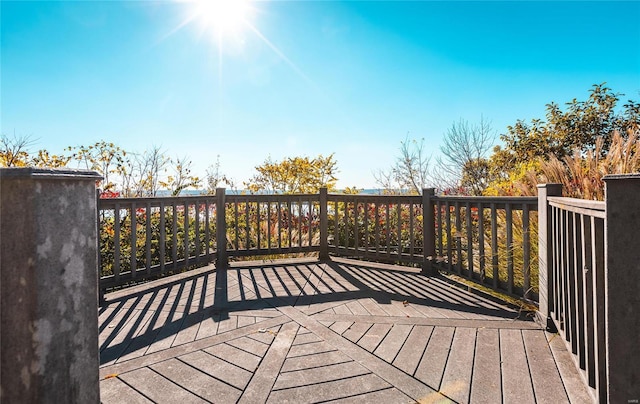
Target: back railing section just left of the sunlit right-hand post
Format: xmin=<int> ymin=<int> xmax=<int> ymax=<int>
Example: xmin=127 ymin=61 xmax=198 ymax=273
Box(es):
xmin=430 ymin=196 xmax=538 ymax=301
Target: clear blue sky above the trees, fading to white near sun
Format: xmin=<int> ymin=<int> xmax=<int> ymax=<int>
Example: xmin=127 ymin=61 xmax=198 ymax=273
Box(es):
xmin=0 ymin=0 xmax=640 ymax=188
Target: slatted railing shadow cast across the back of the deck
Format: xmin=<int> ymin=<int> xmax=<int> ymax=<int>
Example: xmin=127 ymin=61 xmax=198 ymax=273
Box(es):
xmin=100 ymin=260 xmax=532 ymax=363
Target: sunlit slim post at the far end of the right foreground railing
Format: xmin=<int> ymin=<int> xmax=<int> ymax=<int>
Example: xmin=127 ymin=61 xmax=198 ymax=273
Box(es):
xmin=538 ymin=184 xmax=562 ymax=332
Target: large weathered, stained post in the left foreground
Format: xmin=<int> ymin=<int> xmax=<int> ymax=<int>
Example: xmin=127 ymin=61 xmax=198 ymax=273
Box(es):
xmin=0 ymin=168 xmax=101 ymax=403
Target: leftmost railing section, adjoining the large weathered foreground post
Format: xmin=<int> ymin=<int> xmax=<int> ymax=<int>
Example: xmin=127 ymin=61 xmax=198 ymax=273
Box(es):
xmin=98 ymin=196 xmax=217 ymax=290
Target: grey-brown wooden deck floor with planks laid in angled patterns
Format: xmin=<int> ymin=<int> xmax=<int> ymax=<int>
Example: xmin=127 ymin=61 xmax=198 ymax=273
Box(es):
xmin=99 ymin=259 xmax=593 ymax=404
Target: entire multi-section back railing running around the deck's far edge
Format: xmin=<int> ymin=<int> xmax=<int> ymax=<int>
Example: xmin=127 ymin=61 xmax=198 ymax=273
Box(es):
xmin=98 ymin=188 xmax=537 ymax=300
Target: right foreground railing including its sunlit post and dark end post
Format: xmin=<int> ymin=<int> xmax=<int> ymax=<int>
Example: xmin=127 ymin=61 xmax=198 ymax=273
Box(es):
xmin=538 ymin=178 xmax=640 ymax=403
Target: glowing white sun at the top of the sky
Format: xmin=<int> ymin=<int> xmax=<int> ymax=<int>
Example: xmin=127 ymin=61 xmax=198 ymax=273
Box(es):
xmin=192 ymin=0 xmax=250 ymax=38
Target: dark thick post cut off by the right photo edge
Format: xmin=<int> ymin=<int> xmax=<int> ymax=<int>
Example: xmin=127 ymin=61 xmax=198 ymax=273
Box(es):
xmin=598 ymin=174 xmax=640 ymax=403
